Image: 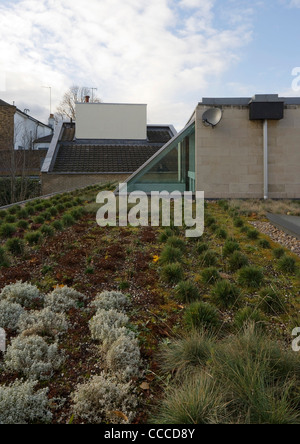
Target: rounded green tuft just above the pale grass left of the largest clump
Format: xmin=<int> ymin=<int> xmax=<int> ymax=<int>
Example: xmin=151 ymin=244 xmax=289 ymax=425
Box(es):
xmin=184 ymin=302 xmax=220 ymax=331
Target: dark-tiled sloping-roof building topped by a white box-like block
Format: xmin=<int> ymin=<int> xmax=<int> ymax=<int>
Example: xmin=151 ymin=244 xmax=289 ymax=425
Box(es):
xmin=41 ymin=101 xmax=176 ymax=194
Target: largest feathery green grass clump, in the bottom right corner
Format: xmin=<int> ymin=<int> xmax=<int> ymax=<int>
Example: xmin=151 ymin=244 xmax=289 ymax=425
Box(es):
xmin=210 ymin=325 xmax=300 ymax=424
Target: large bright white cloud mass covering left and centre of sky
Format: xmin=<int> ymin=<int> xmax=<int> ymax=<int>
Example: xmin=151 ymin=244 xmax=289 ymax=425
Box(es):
xmin=0 ymin=0 xmax=251 ymax=127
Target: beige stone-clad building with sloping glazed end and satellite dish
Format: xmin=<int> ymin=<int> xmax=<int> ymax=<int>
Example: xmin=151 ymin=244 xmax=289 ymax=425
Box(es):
xmin=127 ymin=95 xmax=300 ymax=199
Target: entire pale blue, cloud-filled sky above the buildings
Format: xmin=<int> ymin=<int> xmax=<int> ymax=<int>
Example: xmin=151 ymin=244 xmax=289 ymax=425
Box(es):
xmin=0 ymin=0 xmax=300 ymax=130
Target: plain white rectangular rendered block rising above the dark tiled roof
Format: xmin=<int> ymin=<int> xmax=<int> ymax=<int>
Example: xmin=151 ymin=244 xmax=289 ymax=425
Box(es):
xmin=76 ymin=103 xmax=147 ymax=140
